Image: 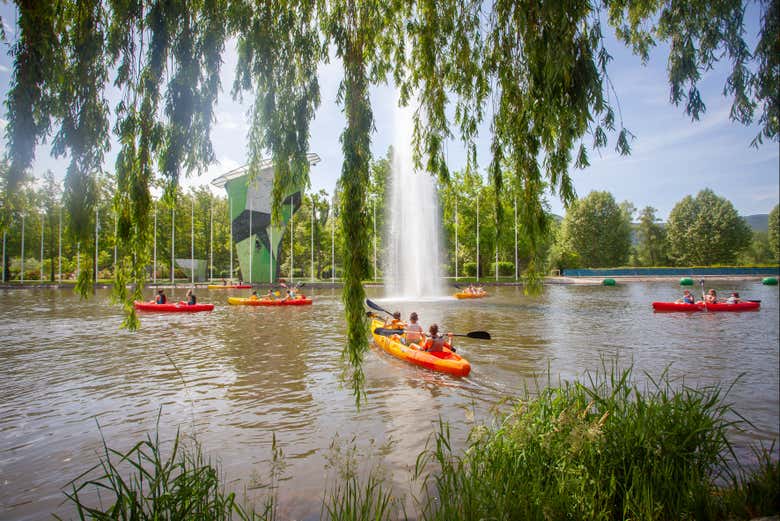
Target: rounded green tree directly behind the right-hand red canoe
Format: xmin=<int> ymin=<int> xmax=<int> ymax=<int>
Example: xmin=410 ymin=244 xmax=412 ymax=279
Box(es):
xmin=667 ymin=189 xmax=752 ymax=266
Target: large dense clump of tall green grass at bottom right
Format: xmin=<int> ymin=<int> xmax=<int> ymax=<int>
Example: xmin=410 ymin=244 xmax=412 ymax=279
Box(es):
xmin=416 ymin=368 xmax=748 ymax=520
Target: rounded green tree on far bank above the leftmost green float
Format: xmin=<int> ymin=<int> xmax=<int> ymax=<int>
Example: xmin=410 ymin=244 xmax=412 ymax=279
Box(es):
xmin=563 ymin=191 xmax=631 ymax=268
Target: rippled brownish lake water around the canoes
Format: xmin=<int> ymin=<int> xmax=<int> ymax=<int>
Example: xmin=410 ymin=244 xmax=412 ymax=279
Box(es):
xmin=0 ymin=281 xmax=780 ymax=519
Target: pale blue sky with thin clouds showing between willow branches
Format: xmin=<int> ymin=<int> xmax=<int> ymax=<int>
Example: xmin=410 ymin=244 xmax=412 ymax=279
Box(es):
xmin=0 ymin=4 xmax=780 ymax=219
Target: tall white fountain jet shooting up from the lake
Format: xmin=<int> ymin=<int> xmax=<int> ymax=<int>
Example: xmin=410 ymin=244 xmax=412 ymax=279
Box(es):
xmin=385 ymin=98 xmax=445 ymax=298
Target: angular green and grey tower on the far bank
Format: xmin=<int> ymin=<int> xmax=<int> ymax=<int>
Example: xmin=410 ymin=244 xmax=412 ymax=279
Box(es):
xmin=211 ymin=154 xmax=320 ymax=283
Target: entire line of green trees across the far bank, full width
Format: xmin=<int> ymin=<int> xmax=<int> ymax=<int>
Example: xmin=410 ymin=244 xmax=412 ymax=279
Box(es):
xmin=4 ymin=160 xmax=780 ymax=281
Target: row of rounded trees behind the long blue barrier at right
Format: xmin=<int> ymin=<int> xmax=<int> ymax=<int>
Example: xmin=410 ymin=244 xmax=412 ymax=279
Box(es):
xmin=549 ymin=189 xmax=780 ymax=269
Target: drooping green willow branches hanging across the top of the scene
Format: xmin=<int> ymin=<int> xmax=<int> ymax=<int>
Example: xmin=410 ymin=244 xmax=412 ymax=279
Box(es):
xmin=3 ymin=0 xmax=780 ymax=402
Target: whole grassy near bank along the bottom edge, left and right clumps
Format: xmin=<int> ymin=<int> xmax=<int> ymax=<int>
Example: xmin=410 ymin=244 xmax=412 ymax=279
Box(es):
xmin=58 ymin=369 xmax=780 ymax=520
